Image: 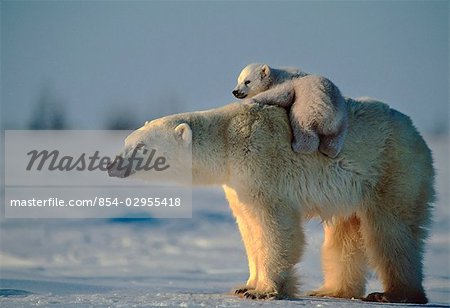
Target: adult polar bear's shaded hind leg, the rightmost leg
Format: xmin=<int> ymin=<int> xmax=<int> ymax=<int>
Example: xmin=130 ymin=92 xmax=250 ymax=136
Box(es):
xmin=361 ymin=208 xmax=428 ymax=304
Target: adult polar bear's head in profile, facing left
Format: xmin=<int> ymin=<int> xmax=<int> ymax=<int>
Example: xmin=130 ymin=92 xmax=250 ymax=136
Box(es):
xmin=108 ymin=116 xmax=192 ymax=184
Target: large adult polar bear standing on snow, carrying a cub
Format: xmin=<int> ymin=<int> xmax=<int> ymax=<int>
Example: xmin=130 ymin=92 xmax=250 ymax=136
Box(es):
xmin=109 ymin=99 xmax=434 ymax=303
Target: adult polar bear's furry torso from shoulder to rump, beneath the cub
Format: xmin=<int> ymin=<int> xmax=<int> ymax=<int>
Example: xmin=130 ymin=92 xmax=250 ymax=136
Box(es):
xmin=224 ymin=99 xmax=432 ymax=215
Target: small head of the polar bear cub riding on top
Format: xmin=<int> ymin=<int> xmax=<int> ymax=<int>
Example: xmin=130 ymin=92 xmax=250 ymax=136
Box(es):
xmin=232 ymin=63 xmax=273 ymax=99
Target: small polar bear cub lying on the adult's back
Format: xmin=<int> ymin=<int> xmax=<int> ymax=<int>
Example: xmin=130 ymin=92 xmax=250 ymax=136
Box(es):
xmin=233 ymin=63 xmax=347 ymax=158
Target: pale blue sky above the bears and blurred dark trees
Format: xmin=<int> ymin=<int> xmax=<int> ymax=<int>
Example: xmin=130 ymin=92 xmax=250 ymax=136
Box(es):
xmin=1 ymin=1 xmax=449 ymax=132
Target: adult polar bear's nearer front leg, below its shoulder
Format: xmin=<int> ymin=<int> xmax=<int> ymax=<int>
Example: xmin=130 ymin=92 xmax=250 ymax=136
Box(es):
xmin=239 ymin=191 xmax=304 ymax=299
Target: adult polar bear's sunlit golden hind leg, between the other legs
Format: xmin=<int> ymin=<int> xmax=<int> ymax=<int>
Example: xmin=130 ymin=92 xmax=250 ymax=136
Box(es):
xmin=308 ymin=215 xmax=366 ymax=298
